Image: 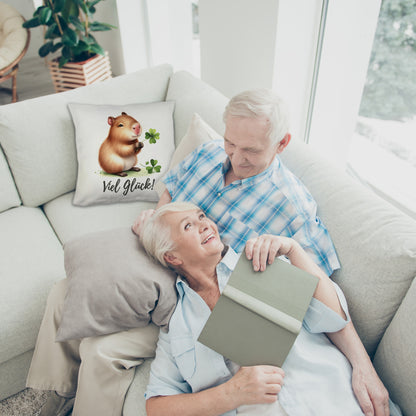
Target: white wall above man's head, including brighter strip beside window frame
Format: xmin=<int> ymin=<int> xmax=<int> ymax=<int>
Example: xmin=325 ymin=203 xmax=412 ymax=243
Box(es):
xmin=199 ymin=0 xmax=322 ymax=140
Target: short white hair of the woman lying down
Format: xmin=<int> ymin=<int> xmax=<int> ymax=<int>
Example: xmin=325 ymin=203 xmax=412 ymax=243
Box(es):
xmin=140 ymin=202 xmax=199 ymax=267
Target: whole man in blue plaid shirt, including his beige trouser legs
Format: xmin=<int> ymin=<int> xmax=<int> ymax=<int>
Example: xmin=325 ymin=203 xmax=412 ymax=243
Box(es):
xmin=27 ymin=90 xmax=388 ymax=416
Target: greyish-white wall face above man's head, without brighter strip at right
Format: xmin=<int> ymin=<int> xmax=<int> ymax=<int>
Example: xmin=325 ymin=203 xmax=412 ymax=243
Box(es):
xmin=199 ymin=0 xmax=279 ymax=97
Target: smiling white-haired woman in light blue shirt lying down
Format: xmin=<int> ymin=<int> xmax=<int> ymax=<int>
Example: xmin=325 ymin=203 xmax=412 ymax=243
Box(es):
xmin=141 ymin=202 xmax=400 ymax=416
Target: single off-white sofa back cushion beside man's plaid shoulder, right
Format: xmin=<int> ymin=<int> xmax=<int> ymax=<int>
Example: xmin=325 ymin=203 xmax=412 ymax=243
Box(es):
xmin=282 ymin=143 xmax=416 ymax=355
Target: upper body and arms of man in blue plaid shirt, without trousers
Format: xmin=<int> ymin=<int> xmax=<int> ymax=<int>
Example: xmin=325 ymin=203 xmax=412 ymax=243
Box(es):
xmin=133 ymin=90 xmax=388 ymax=415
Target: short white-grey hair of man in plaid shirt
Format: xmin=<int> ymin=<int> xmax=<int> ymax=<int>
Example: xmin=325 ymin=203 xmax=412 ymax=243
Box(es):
xmin=223 ymin=89 xmax=289 ymax=144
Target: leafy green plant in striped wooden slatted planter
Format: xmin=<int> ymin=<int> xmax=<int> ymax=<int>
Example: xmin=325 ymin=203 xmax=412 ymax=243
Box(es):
xmin=23 ymin=0 xmax=115 ymax=92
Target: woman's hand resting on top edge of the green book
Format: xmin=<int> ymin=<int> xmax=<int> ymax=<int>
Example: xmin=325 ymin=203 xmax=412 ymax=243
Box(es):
xmin=245 ymin=234 xmax=298 ymax=272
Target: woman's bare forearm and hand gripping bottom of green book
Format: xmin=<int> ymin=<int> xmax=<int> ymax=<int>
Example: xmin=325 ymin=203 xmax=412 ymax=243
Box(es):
xmin=146 ymin=365 xmax=284 ymax=416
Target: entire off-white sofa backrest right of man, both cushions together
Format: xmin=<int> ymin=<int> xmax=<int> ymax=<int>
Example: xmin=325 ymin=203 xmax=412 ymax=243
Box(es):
xmin=282 ymin=143 xmax=416 ymax=415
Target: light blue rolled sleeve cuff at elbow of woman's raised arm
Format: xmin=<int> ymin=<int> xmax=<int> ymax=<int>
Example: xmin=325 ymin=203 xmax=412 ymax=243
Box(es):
xmin=303 ymin=282 xmax=351 ymax=333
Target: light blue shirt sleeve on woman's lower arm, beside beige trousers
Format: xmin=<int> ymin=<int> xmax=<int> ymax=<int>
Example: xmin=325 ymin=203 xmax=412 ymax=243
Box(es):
xmin=144 ymin=331 xmax=191 ymax=400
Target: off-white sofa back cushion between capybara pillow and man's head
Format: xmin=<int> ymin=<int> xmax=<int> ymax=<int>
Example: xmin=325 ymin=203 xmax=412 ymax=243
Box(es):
xmin=166 ymin=71 xmax=228 ymax=144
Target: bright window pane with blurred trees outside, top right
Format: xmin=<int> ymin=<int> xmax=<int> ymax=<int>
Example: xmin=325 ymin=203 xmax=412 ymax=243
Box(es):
xmin=349 ymin=0 xmax=416 ymax=217
